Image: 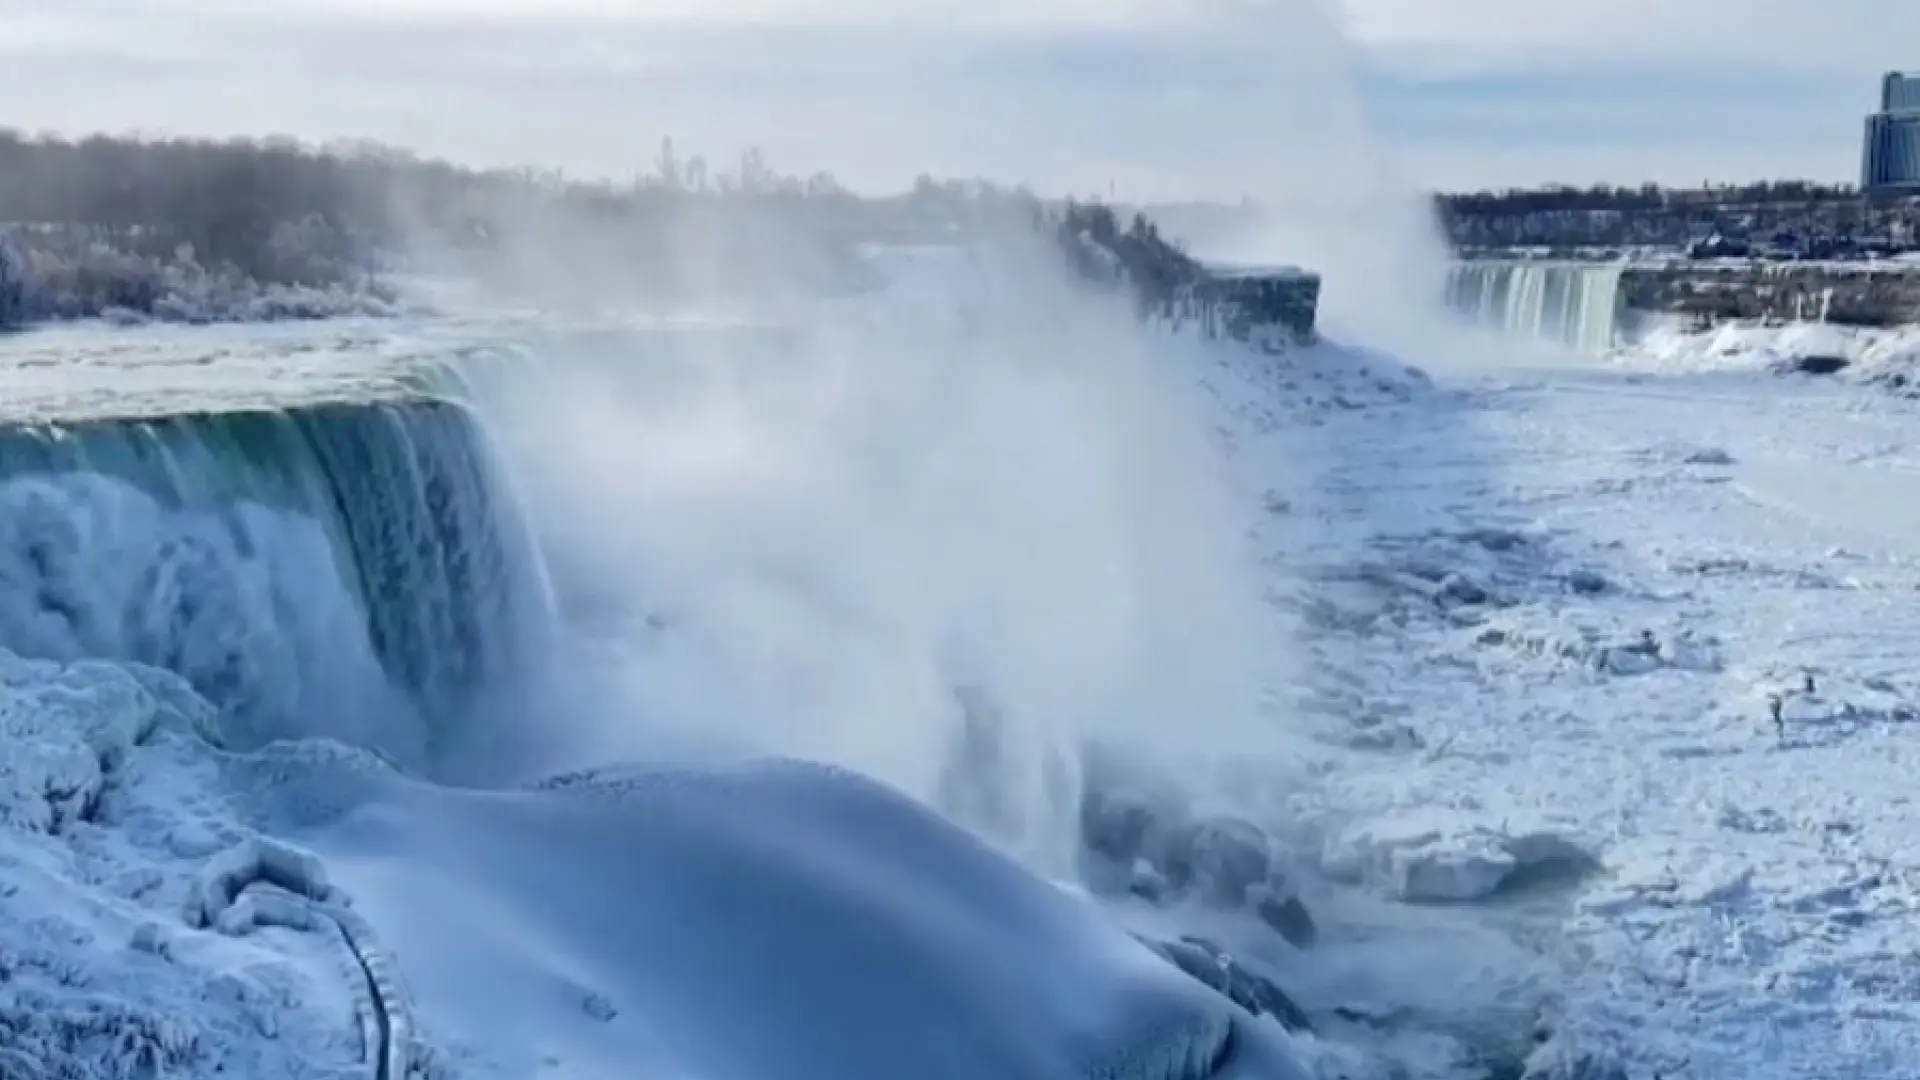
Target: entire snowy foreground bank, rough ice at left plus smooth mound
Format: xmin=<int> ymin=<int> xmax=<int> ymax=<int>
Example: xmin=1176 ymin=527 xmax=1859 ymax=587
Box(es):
xmin=0 ymin=638 xmax=1306 ymax=1080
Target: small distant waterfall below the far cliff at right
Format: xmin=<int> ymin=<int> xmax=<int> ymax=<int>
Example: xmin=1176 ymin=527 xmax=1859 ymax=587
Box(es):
xmin=1446 ymin=259 xmax=1624 ymax=354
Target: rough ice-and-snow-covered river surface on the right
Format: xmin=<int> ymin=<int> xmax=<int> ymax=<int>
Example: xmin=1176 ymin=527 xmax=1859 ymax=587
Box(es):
xmin=1236 ymin=332 xmax=1920 ymax=1080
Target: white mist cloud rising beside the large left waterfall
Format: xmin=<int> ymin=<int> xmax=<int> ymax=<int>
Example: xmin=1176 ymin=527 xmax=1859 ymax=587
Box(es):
xmin=462 ymin=265 xmax=1275 ymax=871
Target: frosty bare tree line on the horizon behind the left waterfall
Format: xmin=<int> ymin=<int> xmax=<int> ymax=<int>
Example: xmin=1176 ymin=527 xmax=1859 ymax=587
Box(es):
xmin=0 ymin=129 xmax=1192 ymax=321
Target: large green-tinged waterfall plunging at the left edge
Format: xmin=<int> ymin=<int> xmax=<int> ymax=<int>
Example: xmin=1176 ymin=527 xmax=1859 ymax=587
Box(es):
xmin=0 ymin=400 xmax=547 ymax=755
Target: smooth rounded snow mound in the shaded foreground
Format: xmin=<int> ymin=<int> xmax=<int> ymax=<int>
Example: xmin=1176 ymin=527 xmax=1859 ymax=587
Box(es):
xmin=261 ymin=761 xmax=1304 ymax=1080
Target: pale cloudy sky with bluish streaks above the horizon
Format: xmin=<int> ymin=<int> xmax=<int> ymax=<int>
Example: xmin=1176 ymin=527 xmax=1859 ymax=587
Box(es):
xmin=0 ymin=0 xmax=1920 ymax=200
